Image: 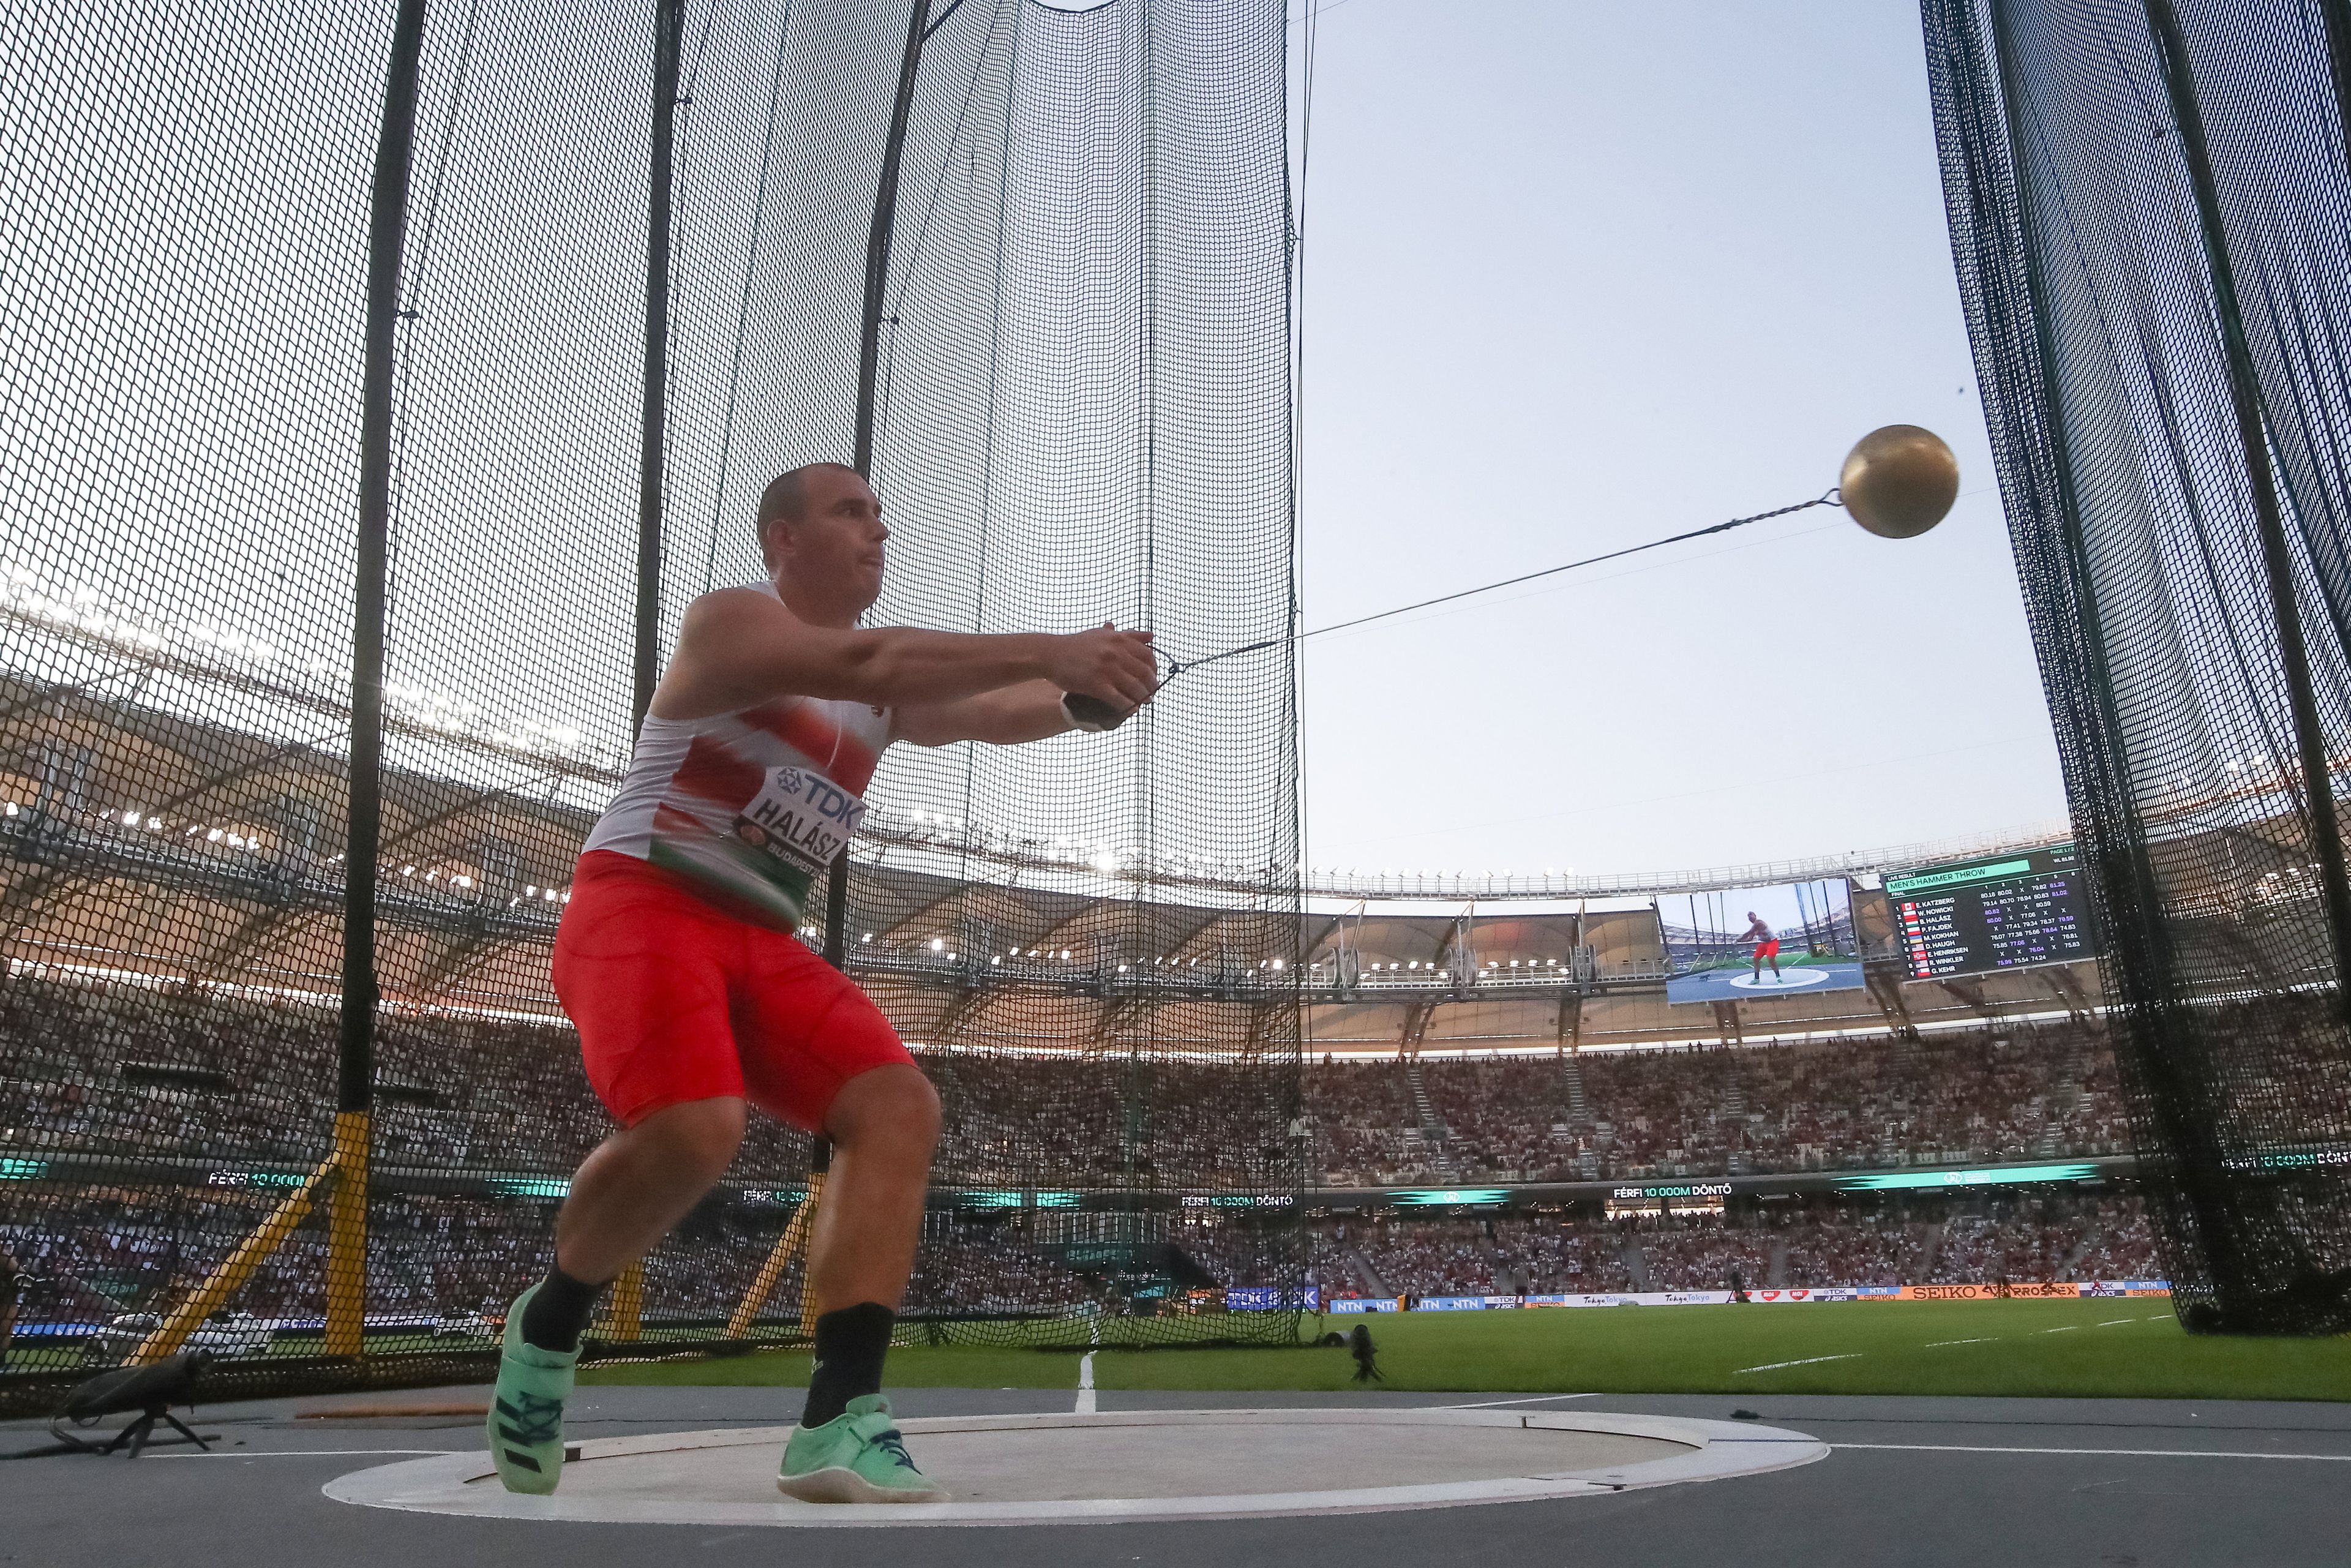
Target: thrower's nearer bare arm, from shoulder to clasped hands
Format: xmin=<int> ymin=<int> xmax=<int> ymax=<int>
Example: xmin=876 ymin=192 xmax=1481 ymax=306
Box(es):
xmin=654 ymin=588 xmax=1159 ymax=738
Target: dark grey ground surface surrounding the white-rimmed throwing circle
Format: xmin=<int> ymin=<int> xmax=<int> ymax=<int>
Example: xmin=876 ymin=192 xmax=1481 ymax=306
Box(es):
xmin=0 ymin=1387 xmax=2351 ymax=1568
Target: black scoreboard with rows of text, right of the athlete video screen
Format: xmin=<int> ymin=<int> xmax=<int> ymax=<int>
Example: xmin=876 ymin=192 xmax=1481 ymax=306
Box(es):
xmin=1886 ymin=844 xmax=2097 ymax=980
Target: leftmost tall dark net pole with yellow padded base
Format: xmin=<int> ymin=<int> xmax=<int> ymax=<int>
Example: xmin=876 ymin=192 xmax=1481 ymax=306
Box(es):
xmin=327 ymin=0 xmax=426 ymax=1356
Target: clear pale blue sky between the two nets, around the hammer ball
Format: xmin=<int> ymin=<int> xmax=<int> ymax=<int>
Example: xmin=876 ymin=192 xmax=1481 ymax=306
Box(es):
xmin=1293 ymin=0 xmax=2064 ymax=872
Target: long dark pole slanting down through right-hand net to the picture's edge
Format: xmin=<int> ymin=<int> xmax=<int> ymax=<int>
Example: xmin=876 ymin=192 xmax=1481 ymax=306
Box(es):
xmin=2147 ymin=0 xmax=2351 ymax=1016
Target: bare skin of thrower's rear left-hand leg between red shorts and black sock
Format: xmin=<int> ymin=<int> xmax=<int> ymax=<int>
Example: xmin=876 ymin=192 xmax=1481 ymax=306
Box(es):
xmin=555 ymin=1100 xmax=743 ymax=1283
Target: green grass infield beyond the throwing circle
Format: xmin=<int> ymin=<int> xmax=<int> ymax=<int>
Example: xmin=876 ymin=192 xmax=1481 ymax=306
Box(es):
xmin=580 ymin=1297 xmax=2351 ymax=1399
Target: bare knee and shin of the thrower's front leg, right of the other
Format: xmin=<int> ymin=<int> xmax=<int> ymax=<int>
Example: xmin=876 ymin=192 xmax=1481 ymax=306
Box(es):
xmin=809 ymin=1065 xmax=938 ymax=1311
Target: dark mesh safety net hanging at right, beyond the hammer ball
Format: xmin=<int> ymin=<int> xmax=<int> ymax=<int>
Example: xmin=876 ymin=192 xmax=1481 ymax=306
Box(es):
xmin=1923 ymin=0 xmax=2351 ymax=1333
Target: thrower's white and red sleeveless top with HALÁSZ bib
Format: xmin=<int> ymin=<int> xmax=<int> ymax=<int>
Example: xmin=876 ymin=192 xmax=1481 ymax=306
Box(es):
xmin=585 ymin=583 xmax=891 ymax=931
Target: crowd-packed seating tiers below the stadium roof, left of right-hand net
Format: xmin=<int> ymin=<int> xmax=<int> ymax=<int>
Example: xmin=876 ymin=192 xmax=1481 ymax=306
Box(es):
xmin=0 ymin=969 xmax=2158 ymax=1363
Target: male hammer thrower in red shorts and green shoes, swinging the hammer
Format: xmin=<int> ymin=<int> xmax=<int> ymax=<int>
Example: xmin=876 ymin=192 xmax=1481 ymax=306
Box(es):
xmin=489 ymin=463 xmax=1157 ymax=1502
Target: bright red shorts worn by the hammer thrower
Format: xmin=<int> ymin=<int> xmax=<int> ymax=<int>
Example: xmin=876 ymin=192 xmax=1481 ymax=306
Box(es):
xmin=555 ymin=849 xmax=915 ymax=1133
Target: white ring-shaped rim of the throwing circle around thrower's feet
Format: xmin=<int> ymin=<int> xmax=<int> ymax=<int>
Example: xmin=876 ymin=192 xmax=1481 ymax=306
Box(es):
xmin=320 ymin=1406 xmax=1829 ymax=1528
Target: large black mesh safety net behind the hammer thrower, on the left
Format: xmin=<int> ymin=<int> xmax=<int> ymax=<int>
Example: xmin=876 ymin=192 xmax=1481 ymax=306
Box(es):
xmin=0 ymin=0 xmax=1310 ymax=1406
